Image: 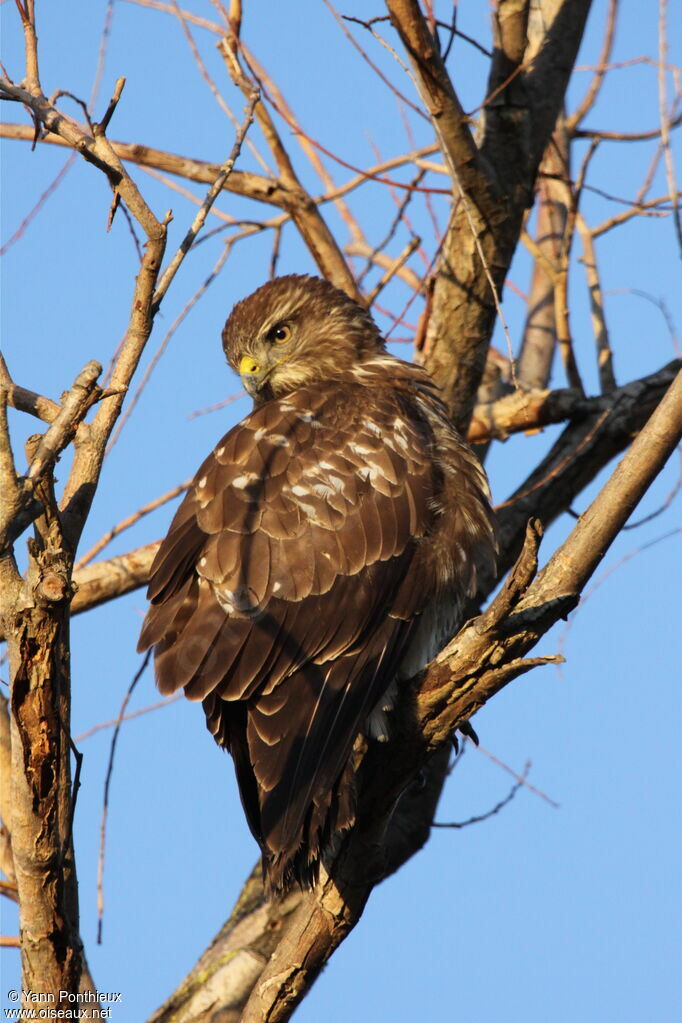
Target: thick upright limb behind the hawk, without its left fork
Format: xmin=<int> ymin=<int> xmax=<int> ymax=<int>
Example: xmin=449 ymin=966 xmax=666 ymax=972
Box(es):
xmin=413 ymin=0 xmax=589 ymax=432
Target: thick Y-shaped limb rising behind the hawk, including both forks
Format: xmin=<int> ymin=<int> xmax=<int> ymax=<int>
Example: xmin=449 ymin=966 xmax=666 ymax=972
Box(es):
xmin=394 ymin=0 xmax=590 ymax=433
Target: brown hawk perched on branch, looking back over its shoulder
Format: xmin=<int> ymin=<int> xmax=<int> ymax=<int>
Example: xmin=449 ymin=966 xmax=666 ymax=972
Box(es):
xmin=138 ymin=274 xmax=496 ymax=898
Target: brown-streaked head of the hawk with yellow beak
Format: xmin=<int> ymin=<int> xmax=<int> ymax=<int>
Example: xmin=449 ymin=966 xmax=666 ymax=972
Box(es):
xmin=223 ymin=274 xmax=383 ymax=404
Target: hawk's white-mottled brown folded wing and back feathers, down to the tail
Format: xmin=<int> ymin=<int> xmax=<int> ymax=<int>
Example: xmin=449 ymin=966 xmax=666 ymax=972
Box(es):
xmin=140 ymin=383 xmax=437 ymax=880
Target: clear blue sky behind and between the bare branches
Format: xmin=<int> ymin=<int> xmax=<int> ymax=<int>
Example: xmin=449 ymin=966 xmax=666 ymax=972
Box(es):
xmin=0 ymin=0 xmax=682 ymax=1023
